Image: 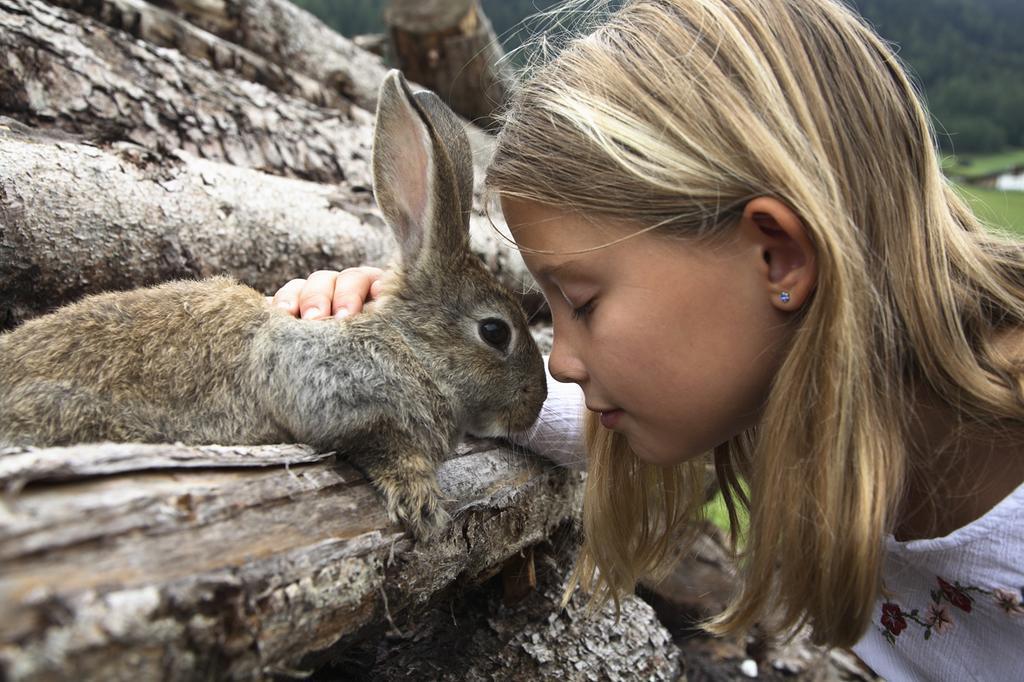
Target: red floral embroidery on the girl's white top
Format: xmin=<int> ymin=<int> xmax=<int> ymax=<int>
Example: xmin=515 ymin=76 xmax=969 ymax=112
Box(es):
xmin=879 ymin=576 xmax=1024 ymax=646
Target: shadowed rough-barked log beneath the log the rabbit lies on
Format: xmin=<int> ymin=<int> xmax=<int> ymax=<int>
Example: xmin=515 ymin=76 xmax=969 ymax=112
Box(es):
xmin=314 ymin=527 xmax=685 ymax=682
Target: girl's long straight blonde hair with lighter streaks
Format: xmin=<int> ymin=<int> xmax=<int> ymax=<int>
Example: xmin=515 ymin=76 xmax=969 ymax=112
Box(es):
xmin=487 ymin=0 xmax=1024 ymax=645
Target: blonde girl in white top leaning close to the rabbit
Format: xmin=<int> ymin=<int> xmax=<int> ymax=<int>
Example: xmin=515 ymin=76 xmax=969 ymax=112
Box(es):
xmin=276 ymin=0 xmax=1024 ymax=679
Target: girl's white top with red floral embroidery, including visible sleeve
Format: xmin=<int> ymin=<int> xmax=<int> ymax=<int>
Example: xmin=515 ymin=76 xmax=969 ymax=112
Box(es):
xmin=516 ymin=357 xmax=1024 ymax=682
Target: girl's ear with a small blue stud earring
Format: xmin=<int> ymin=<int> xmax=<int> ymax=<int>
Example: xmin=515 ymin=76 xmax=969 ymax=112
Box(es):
xmin=740 ymin=192 xmax=818 ymax=311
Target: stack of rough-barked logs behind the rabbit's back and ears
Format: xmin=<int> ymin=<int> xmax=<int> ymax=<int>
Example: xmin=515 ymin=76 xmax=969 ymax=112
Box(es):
xmin=0 ymin=0 xmax=542 ymax=329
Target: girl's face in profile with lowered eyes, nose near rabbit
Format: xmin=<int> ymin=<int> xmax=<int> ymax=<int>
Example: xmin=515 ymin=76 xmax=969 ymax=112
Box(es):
xmin=502 ymin=199 xmax=800 ymax=464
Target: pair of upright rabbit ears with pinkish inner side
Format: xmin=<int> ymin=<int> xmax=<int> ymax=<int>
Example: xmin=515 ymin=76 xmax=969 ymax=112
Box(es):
xmin=373 ymin=70 xmax=473 ymax=268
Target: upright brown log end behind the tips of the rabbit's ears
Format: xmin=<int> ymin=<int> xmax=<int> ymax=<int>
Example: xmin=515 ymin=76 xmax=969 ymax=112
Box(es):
xmin=384 ymin=0 xmax=511 ymax=127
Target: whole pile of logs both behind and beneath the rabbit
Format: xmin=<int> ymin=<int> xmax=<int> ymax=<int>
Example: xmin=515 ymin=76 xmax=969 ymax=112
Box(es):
xmin=0 ymin=0 xmax=680 ymax=680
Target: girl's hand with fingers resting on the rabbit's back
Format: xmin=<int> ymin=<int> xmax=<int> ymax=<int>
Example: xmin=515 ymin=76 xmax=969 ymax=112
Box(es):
xmin=271 ymin=266 xmax=384 ymax=319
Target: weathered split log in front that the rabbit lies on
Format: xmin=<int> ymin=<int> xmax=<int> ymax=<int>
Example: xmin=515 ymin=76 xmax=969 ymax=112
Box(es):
xmin=0 ymin=441 xmax=582 ymax=681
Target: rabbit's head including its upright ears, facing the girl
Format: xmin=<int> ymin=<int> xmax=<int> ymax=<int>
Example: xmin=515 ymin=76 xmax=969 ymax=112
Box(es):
xmin=373 ymin=71 xmax=547 ymax=436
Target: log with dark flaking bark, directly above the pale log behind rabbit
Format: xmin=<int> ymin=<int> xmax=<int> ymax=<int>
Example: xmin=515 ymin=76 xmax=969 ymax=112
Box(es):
xmin=0 ymin=0 xmax=371 ymax=184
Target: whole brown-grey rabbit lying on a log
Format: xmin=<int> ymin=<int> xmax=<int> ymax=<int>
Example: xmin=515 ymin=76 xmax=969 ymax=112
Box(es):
xmin=0 ymin=70 xmax=547 ymax=540
